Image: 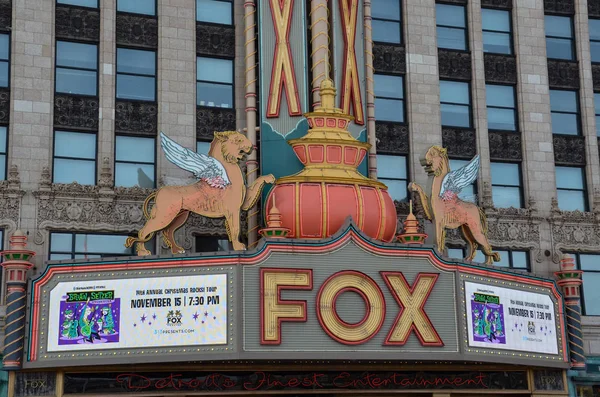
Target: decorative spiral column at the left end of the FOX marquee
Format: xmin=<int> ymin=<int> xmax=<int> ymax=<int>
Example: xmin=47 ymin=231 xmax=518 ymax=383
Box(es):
xmin=2 ymin=230 xmax=35 ymax=371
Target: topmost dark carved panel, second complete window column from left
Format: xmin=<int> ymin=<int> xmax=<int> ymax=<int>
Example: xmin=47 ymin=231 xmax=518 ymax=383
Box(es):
xmin=117 ymin=12 xmax=158 ymax=48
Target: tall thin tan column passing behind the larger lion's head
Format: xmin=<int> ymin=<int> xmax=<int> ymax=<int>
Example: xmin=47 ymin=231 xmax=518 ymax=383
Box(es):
xmin=244 ymin=0 xmax=258 ymax=248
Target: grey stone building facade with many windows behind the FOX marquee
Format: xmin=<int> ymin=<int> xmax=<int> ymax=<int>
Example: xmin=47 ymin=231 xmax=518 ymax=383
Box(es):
xmin=0 ymin=0 xmax=600 ymax=397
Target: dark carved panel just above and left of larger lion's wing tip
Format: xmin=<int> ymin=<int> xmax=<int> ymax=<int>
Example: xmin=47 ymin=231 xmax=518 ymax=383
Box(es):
xmin=115 ymin=100 xmax=158 ymax=136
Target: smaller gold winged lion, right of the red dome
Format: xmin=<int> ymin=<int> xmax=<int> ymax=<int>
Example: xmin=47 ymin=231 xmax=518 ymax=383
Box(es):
xmin=409 ymin=146 xmax=500 ymax=265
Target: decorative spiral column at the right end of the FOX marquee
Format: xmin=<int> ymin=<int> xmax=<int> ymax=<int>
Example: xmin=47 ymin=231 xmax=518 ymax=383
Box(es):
xmin=554 ymin=255 xmax=585 ymax=369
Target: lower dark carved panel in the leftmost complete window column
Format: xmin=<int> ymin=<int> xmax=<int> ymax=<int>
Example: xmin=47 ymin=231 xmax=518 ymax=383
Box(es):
xmin=54 ymin=94 xmax=99 ymax=130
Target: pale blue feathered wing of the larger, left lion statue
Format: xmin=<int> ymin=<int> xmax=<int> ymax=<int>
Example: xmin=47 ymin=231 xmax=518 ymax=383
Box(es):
xmin=160 ymin=131 xmax=231 ymax=189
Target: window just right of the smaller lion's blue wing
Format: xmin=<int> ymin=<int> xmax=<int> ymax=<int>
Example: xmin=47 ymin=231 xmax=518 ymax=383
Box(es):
xmin=491 ymin=162 xmax=523 ymax=208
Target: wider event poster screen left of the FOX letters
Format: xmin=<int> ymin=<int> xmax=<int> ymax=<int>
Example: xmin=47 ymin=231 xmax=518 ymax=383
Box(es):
xmin=48 ymin=274 xmax=227 ymax=352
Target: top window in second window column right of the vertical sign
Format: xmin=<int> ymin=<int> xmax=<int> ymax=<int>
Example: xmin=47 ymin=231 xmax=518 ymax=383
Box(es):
xmin=435 ymin=4 xmax=467 ymax=50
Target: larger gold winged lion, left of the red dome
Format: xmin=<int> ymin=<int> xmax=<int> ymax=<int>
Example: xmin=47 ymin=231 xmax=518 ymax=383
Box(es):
xmin=125 ymin=131 xmax=275 ymax=256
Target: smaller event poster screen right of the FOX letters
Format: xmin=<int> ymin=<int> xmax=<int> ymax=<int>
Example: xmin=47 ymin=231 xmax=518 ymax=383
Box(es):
xmin=465 ymin=282 xmax=558 ymax=354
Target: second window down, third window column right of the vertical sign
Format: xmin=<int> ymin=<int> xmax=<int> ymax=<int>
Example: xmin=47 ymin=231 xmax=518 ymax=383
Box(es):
xmin=485 ymin=84 xmax=517 ymax=131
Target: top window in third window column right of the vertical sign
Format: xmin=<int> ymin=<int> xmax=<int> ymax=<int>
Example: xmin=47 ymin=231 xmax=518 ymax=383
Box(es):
xmin=481 ymin=8 xmax=512 ymax=55
